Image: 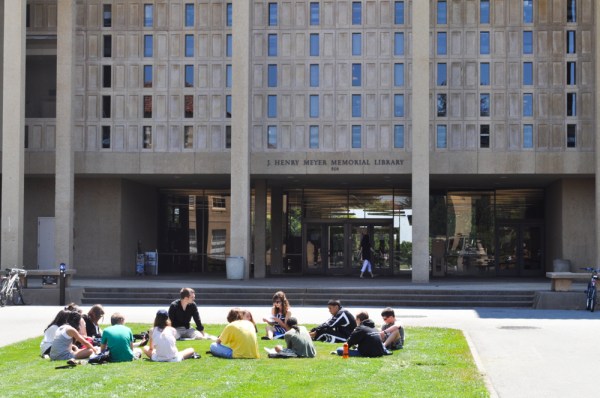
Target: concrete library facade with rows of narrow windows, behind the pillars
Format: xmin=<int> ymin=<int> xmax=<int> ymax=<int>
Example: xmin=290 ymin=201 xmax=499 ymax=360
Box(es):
xmin=0 ymin=0 xmax=600 ymax=282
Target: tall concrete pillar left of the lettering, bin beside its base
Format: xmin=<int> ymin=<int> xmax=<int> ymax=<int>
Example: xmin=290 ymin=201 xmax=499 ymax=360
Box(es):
xmin=230 ymin=1 xmax=252 ymax=279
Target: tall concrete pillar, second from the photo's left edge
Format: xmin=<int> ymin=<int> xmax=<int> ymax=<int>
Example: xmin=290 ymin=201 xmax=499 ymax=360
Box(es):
xmin=54 ymin=0 xmax=76 ymax=268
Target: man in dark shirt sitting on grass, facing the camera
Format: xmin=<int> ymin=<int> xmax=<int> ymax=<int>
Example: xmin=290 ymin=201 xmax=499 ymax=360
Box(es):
xmin=169 ymin=287 xmax=216 ymax=340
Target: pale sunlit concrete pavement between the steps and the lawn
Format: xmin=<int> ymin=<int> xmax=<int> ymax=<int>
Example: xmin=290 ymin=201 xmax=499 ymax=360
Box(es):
xmin=0 ymin=306 xmax=600 ymax=398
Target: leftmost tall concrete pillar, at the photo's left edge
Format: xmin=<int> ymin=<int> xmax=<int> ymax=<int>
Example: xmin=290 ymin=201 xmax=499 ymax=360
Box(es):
xmin=0 ymin=1 xmax=26 ymax=267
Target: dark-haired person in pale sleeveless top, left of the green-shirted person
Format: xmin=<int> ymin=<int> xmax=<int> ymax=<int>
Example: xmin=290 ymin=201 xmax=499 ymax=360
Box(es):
xmin=48 ymin=311 xmax=97 ymax=361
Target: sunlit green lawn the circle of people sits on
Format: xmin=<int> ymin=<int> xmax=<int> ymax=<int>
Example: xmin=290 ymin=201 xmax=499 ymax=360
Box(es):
xmin=0 ymin=324 xmax=489 ymax=398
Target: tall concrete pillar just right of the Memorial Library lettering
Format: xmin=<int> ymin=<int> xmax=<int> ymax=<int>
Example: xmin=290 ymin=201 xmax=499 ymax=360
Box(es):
xmin=411 ymin=1 xmax=430 ymax=283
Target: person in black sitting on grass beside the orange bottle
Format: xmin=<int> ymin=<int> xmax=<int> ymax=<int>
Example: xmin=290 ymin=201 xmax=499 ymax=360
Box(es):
xmin=337 ymin=312 xmax=389 ymax=358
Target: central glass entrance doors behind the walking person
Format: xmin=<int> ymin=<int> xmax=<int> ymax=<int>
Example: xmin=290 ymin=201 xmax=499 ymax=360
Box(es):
xmin=302 ymin=219 xmax=394 ymax=275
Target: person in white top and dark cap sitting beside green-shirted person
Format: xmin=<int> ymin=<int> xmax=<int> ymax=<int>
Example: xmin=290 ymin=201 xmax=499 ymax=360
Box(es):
xmin=144 ymin=310 xmax=200 ymax=362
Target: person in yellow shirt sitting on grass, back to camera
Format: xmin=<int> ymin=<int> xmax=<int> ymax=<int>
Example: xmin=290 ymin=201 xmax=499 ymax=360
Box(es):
xmin=210 ymin=308 xmax=260 ymax=359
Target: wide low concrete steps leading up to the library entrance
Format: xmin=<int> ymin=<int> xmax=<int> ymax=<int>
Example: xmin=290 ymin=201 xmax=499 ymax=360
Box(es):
xmin=82 ymin=287 xmax=535 ymax=308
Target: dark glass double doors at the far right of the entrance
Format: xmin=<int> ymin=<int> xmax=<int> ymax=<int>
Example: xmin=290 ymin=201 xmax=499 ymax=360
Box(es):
xmin=496 ymin=222 xmax=544 ymax=276
